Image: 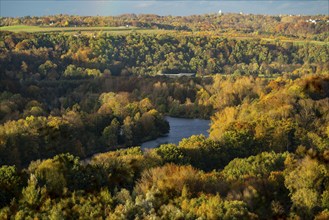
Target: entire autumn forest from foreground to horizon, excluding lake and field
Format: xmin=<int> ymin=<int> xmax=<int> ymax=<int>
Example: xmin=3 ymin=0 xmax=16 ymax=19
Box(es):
xmin=0 ymin=14 xmax=329 ymax=219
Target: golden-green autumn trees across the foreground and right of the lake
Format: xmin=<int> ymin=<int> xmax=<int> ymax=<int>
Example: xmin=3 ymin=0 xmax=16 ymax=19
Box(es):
xmin=0 ymin=75 xmax=329 ymax=219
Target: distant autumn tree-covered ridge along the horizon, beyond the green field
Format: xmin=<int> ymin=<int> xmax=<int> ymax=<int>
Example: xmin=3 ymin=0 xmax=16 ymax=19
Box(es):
xmin=0 ymin=13 xmax=329 ymax=41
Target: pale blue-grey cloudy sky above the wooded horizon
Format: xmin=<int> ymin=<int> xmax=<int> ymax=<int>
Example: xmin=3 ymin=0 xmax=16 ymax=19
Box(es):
xmin=0 ymin=0 xmax=329 ymax=17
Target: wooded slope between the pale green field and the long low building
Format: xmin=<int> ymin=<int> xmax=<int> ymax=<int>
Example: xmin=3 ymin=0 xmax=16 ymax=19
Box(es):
xmin=0 ymin=31 xmax=329 ymax=80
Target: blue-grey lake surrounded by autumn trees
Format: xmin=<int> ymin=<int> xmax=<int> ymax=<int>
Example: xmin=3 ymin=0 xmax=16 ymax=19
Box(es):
xmin=141 ymin=117 xmax=210 ymax=149
